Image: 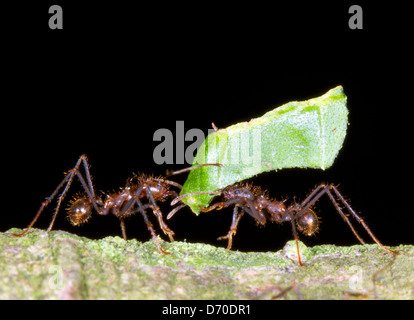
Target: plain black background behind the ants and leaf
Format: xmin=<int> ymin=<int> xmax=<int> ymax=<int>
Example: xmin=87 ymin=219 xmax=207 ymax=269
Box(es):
xmin=0 ymin=1 xmax=414 ymax=251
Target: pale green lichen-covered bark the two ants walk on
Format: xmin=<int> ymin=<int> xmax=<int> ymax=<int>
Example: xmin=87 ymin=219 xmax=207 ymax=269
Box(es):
xmin=0 ymin=229 xmax=414 ymax=299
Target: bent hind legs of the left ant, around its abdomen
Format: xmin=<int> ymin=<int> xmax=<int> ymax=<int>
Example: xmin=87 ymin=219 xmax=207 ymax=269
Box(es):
xmin=13 ymin=155 xmax=99 ymax=237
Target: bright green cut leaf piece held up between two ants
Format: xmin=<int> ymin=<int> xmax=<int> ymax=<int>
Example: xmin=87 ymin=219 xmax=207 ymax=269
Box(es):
xmin=181 ymin=86 xmax=348 ymax=214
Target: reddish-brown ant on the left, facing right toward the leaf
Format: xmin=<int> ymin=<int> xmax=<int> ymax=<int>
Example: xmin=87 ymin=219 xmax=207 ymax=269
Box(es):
xmin=13 ymin=155 xmax=221 ymax=254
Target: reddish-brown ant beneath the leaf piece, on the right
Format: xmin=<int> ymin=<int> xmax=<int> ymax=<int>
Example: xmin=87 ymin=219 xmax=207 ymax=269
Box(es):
xmin=167 ymin=183 xmax=397 ymax=266
